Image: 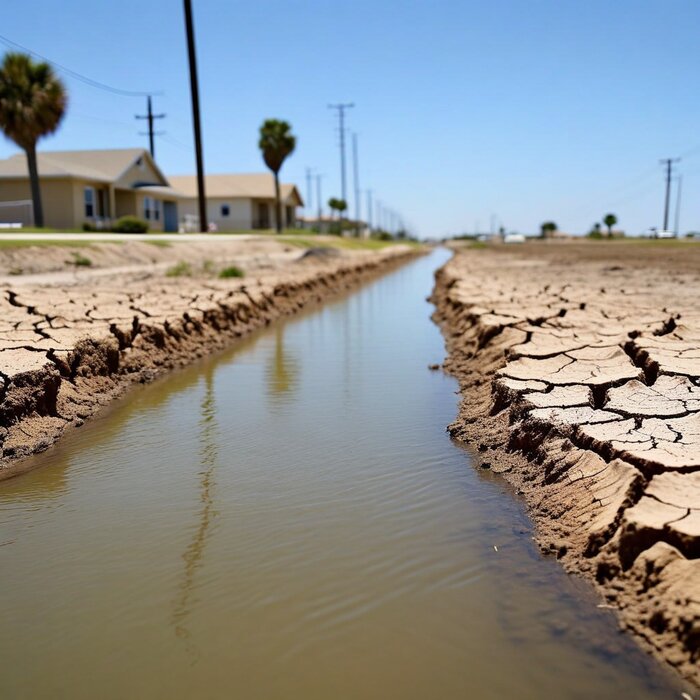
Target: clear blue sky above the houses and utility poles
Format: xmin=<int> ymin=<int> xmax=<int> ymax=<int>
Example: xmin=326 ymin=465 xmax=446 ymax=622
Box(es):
xmin=0 ymin=0 xmax=700 ymax=236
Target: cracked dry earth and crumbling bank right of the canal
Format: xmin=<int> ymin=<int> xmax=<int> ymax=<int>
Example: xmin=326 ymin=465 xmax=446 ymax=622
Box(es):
xmin=433 ymin=242 xmax=700 ymax=685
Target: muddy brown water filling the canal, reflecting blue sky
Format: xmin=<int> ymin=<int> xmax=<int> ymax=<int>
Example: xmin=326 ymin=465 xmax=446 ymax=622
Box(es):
xmin=0 ymin=251 xmax=681 ymax=700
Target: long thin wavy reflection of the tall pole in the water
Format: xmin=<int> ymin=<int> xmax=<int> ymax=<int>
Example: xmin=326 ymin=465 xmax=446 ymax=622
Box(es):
xmin=173 ymin=364 xmax=218 ymax=664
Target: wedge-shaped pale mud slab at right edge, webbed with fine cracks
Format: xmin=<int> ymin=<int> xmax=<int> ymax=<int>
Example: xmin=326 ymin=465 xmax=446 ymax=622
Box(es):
xmin=579 ymin=413 xmax=700 ymax=469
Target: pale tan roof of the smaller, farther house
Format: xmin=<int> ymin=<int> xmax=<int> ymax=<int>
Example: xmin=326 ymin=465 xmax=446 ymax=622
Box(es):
xmin=168 ymin=173 xmax=304 ymax=206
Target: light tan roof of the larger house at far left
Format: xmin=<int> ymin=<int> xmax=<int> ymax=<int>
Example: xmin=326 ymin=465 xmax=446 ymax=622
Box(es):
xmin=0 ymin=148 xmax=165 ymax=182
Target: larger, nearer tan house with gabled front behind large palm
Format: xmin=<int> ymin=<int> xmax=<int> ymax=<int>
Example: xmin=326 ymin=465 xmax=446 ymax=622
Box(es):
xmin=0 ymin=148 xmax=180 ymax=231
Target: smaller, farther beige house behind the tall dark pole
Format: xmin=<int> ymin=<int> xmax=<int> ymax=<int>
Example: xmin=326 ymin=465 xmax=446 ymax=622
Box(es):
xmin=168 ymin=173 xmax=304 ymax=231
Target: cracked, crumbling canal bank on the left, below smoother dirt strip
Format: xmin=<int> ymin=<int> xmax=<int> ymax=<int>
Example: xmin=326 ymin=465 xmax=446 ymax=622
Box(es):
xmin=0 ymin=247 xmax=425 ymax=480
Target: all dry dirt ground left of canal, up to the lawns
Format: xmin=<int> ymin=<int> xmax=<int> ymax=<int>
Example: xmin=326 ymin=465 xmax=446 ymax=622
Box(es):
xmin=0 ymin=240 xmax=416 ymax=479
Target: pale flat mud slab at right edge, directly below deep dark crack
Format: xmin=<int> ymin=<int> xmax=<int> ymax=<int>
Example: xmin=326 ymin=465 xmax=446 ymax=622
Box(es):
xmin=605 ymin=375 xmax=700 ymax=418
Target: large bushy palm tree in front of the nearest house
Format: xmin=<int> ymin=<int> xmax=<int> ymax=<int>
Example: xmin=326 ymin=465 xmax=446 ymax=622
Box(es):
xmin=0 ymin=53 xmax=68 ymax=228
